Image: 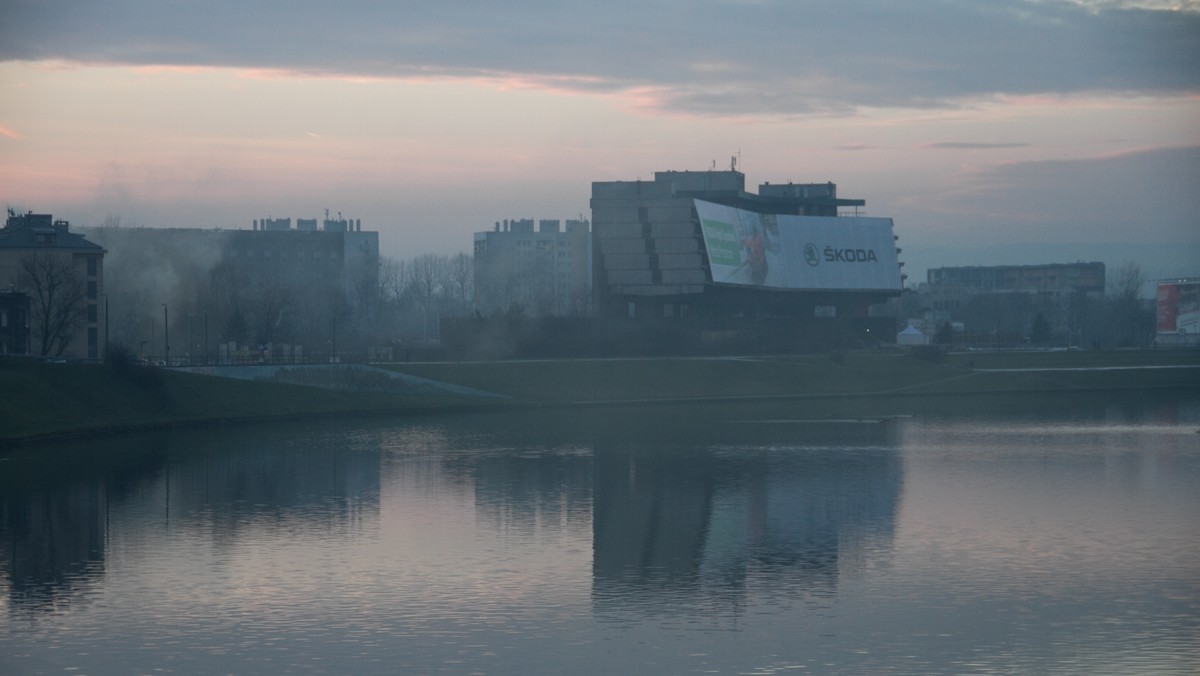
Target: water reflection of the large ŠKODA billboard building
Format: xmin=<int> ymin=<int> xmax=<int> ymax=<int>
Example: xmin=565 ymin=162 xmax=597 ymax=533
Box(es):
xmin=593 ymin=420 xmax=902 ymax=614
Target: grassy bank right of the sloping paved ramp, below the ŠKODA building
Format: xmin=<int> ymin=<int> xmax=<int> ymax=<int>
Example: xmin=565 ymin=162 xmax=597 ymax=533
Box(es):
xmin=389 ymin=351 xmax=1200 ymax=403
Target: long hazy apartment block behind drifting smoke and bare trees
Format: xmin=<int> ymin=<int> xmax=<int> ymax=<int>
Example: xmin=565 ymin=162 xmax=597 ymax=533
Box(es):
xmin=82 ymin=219 xmax=379 ymax=363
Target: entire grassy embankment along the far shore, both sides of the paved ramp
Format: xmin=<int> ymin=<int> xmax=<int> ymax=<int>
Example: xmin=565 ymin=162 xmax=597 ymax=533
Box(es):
xmin=0 ymin=351 xmax=1200 ymax=444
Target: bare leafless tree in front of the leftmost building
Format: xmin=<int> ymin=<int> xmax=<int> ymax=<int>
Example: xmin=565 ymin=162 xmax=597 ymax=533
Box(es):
xmin=17 ymin=251 xmax=88 ymax=357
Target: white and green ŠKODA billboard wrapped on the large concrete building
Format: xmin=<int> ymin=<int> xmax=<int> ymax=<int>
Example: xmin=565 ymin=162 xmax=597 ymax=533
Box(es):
xmin=696 ymin=199 xmax=901 ymax=291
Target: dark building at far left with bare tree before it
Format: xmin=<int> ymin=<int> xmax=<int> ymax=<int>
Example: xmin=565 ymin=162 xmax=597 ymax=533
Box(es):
xmin=0 ymin=211 xmax=107 ymax=359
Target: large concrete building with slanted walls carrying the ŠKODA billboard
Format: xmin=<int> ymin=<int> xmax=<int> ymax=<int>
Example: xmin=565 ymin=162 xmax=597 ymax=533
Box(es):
xmin=592 ymin=169 xmax=902 ymax=342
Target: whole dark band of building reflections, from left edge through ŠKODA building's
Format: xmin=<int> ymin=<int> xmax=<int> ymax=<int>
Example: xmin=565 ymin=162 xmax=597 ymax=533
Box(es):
xmin=0 ymin=406 xmax=902 ymax=629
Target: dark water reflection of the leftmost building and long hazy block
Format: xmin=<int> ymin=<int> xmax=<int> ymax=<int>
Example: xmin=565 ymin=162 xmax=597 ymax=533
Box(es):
xmin=0 ymin=426 xmax=379 ymax=611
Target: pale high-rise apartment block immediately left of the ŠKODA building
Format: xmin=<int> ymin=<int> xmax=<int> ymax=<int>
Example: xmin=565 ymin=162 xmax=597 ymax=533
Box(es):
xmin=474 ymin=219 xmax=592 ymax=317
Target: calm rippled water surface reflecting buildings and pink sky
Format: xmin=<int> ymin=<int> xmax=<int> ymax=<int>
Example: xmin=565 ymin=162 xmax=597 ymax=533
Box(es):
xmin=0 ymin=391 xmax=1200 ymax=675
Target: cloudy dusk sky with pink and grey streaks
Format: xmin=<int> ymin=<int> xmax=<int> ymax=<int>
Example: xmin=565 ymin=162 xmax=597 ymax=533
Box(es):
xmin=0 ymin=0 xmax=1200 ymax=282
